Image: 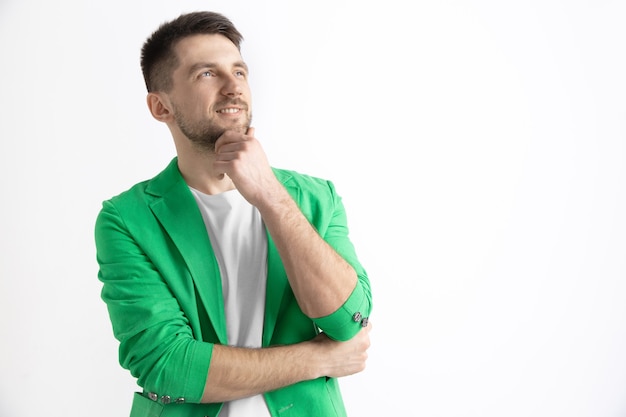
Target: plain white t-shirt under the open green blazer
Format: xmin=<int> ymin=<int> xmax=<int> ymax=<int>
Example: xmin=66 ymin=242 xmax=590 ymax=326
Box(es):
xmin=190 ymin=187 xmax=270 ymax=417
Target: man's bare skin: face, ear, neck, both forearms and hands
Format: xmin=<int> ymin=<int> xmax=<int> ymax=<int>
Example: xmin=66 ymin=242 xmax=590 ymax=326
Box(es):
xmin=147 ymin=35 xmax=371 ymax=402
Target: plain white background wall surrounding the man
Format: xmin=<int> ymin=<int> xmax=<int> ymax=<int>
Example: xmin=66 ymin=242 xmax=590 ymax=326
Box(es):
xmin=0 ymin=0 xmax=626 ymax=417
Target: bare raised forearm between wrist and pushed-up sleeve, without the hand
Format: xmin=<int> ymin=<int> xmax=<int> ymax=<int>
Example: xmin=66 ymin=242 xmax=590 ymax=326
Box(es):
xmin=258 ymin=185 xmax=357 ymax=318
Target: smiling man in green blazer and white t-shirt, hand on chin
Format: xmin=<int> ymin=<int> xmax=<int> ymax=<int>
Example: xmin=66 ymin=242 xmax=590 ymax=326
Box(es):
xmin=95 ymin=12 xmax=371 ymax=417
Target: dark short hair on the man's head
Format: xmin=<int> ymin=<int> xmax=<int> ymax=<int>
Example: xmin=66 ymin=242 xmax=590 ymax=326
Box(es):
xmin=141 ymin=12 xmax=243 ymax=92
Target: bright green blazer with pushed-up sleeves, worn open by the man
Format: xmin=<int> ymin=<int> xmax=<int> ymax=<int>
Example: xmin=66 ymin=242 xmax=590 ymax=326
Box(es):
xmin=95 ymin=158 xmax=371 ymax=417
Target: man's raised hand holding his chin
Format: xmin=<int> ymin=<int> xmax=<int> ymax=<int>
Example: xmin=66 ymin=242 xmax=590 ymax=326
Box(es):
xmin=213 ymin=127 xmax=280 ymax=206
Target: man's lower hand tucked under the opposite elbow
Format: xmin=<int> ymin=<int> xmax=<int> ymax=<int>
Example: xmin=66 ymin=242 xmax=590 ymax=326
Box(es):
xmin=311 ymin=322 xmax=372 ymax=378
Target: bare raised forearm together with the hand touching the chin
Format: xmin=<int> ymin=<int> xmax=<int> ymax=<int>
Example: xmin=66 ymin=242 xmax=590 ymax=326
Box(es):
xmin=214 ymin=129 xmax=357 ymax=318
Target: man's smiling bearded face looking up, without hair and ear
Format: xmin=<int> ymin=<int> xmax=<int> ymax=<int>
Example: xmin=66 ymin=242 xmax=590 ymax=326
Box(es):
xmin=168 ymin=35 xmax=252 ymax=151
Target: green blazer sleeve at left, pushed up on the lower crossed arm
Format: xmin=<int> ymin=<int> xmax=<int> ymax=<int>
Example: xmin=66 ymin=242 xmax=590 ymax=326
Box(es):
xmin=95 ymin=200 xmax=213 ymax=402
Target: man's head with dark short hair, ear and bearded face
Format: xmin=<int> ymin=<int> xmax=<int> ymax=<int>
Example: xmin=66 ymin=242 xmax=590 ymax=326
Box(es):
xmin=141 ymin=12 xmax=252 ymax=151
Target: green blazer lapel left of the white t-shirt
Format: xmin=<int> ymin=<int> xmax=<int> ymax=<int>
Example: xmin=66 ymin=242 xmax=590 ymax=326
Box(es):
xmin=146 ymin=158 xmax=227 ymax=344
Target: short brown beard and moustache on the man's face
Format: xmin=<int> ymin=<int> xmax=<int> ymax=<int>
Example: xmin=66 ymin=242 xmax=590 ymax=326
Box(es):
xmin=174 ymin=101 xmax=252 ymax=152
